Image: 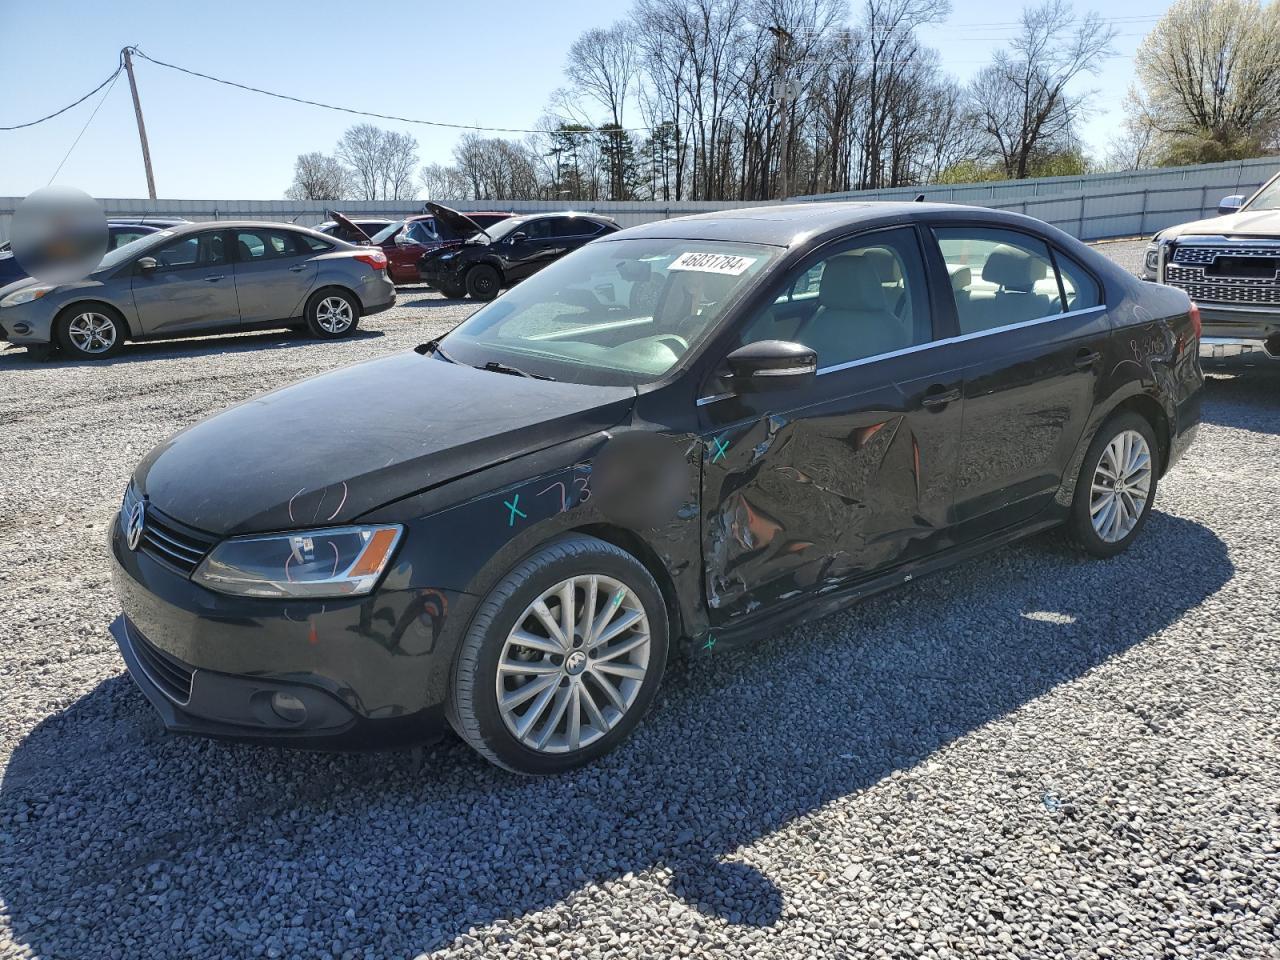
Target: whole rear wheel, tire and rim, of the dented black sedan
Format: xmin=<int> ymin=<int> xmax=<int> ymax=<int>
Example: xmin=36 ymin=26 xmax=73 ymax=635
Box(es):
xmin=1068 ymin=411 xmax=1160 ymax=557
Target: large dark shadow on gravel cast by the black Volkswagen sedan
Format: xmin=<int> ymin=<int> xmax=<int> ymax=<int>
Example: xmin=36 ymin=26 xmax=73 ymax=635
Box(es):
xmin=0 ymin=512 xmax=1233 ymax=956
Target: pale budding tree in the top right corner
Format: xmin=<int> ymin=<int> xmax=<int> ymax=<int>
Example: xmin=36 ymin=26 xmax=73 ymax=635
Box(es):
xmin=1129 ymin=0 xmax=1280 ymax=163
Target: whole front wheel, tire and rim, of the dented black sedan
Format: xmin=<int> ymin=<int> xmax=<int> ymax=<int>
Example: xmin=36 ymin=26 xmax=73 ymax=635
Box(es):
xmin=448 ymin=535 xmax=668 ymax=774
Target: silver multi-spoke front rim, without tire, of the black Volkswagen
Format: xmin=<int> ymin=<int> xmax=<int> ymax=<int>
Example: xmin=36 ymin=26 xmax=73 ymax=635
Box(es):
xmin=497 ymin=573 xmax=650 ymax=753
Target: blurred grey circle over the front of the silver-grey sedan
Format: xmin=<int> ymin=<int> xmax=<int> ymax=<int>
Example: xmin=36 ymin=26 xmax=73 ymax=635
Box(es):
xmin=10 ymin=187 xmax=106 ymax=283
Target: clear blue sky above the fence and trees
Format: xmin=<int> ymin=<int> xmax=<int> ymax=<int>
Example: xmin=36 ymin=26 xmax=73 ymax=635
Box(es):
xmin=0 ymin=0 xmax=1169 ymax=200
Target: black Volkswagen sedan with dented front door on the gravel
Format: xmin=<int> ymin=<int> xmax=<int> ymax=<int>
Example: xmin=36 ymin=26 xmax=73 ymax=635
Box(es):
xmin=110 ymin=204 xmax=1203 ymax=773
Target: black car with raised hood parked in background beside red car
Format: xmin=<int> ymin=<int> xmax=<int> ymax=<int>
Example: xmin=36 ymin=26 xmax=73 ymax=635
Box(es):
xmin=417 ymin=204 xmax=618 ymax=300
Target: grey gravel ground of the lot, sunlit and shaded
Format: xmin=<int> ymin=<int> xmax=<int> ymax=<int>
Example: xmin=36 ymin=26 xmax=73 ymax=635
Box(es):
xmin=0 ymin=257 xmax=1280 ymax=960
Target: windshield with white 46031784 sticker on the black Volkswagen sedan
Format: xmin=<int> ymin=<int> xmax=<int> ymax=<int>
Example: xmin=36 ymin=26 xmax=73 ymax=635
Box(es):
xmin=440 ymin=239 xmax=781 ymax=385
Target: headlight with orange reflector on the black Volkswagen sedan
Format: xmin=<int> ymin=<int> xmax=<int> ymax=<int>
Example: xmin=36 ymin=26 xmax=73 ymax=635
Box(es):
xmin=192 ymin=524 xmax=404 ymax=598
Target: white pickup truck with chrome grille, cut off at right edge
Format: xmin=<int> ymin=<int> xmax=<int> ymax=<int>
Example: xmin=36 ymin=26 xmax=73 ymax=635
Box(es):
xmin=1143 ymin=168 xmax=1280 ymax=360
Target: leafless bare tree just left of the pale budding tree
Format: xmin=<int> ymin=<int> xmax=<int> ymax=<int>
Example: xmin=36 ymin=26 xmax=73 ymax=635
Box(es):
xmin=969 ymin=0 xmax=1115 ymax=177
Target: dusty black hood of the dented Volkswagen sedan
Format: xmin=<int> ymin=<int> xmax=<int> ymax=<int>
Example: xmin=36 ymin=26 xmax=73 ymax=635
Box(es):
xmin=134 ymin=352 xmax=635 ymax=536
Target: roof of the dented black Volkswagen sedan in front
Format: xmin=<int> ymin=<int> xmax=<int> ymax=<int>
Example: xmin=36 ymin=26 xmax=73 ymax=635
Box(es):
xmin=609 ymin=201 xmax=1060 ymax=247
